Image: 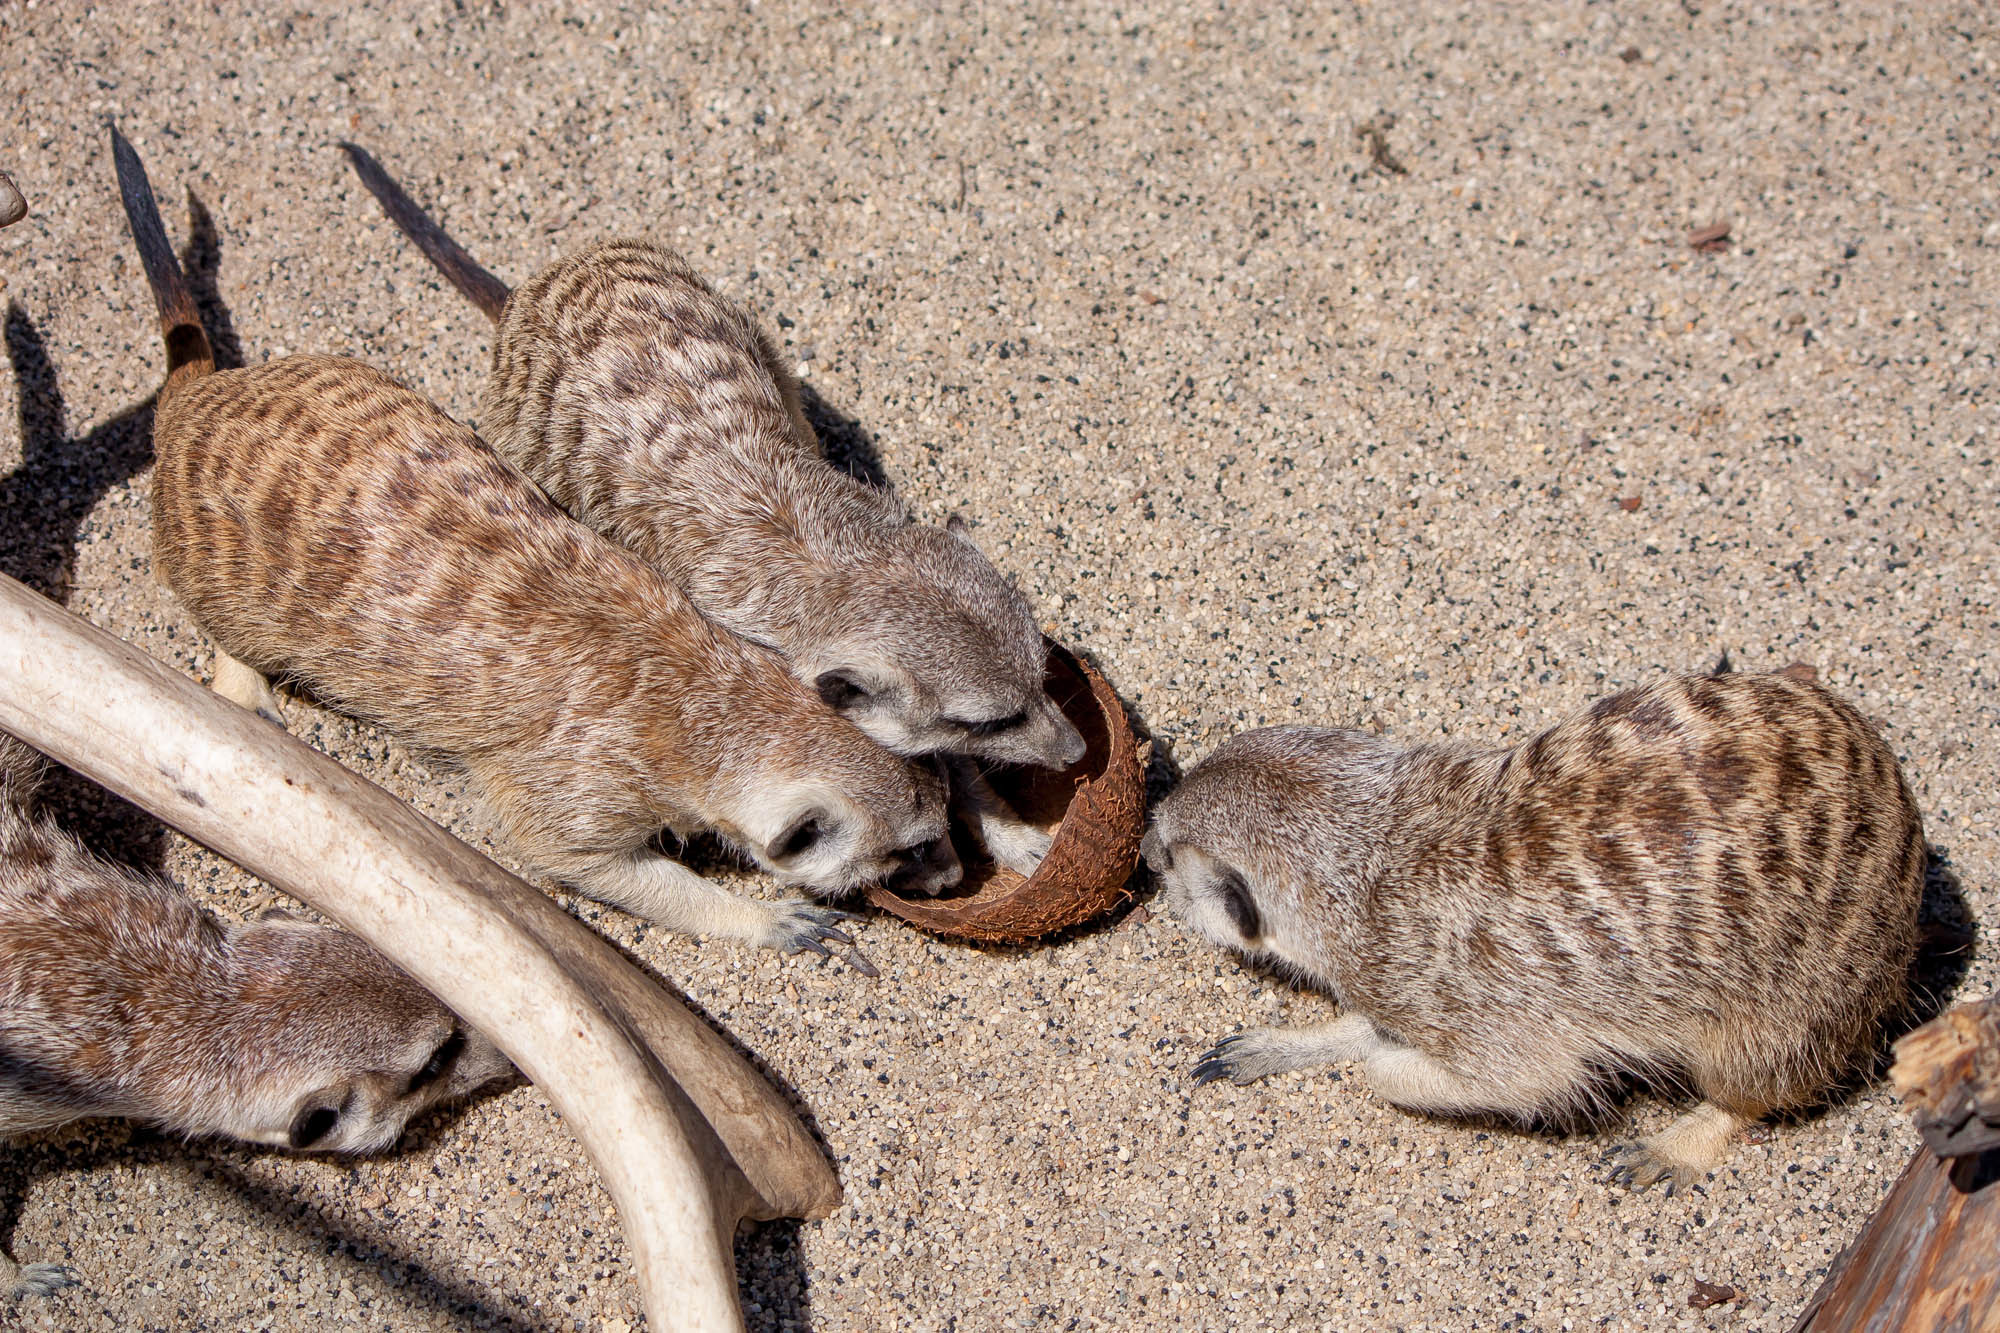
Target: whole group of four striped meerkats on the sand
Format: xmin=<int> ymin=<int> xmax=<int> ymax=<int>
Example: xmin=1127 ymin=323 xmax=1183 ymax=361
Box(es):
xmin=0 ymin=114 xmax=1926 ymax=1289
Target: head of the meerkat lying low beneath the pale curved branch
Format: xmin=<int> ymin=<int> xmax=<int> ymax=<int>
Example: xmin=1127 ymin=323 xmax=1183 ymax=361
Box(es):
xmin=212 ymin=913 xmax=512 ymax=1153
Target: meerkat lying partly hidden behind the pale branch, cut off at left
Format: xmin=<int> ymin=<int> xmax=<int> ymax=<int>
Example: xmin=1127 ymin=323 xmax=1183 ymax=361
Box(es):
xmin=0 ymin=733 xmax=512 ymax=1295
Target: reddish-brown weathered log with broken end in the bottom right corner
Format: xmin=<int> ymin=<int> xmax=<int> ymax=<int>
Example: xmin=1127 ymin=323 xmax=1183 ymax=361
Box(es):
xmin=1792 ymin=984 xmax=2000 ymax=1333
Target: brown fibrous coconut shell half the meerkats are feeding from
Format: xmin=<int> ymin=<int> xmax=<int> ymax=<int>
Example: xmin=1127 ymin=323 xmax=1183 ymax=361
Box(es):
xmin=868 ymin=640 xmax=1146 ymax=943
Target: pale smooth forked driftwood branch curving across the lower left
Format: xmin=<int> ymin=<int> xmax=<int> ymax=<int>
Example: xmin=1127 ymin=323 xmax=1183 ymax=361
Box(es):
xmin=0 ymin=576 xmax=840 ymax=1329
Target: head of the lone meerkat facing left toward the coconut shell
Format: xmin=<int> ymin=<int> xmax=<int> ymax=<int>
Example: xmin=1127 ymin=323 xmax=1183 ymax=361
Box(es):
xmin=1140 ymin=727 xmax=1394 ymax=977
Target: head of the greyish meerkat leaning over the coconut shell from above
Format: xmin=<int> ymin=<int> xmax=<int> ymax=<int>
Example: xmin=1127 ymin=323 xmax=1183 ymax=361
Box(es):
xmin=800 ymin=522 xmax=1084 ymax=769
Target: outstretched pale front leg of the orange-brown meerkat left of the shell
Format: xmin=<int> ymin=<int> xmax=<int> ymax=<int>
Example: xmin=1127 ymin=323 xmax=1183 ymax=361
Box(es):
xmin=566 ymin=851 xmax=854 ymax=957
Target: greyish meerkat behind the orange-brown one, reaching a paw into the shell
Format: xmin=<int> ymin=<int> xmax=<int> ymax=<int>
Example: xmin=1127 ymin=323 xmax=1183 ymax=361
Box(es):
xmin=342 ymin=144 xmax=1084 ymax=875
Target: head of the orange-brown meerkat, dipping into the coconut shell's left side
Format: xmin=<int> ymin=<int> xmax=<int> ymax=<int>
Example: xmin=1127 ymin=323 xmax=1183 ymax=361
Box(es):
xmin=722 ymin=736 xmax=962 ymax=897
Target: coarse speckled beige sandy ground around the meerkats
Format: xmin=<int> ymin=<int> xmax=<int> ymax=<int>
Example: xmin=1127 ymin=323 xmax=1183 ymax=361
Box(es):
xmin=0 ymin=0 xmax=2000 ymax=1333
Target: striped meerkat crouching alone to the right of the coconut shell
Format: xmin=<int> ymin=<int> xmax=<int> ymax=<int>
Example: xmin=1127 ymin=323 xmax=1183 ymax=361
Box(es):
xmin=1144 ymin=675 xmax=1926 ymax=1193
